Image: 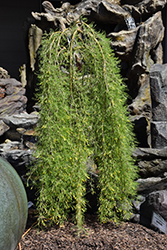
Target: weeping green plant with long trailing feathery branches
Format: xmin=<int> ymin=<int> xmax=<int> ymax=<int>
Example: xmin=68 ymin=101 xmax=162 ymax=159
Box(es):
xmin=30 ymin=21 xmax=136 ymax=227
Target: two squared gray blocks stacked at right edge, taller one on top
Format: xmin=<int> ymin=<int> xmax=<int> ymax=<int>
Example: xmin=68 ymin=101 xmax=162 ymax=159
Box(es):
xmin=150 ymin=64 xmax=167 ymax=148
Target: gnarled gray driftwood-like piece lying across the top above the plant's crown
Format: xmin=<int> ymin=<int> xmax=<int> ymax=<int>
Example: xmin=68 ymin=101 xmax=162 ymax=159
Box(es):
xmin=32 ymin=0 xmax=132 ymax=30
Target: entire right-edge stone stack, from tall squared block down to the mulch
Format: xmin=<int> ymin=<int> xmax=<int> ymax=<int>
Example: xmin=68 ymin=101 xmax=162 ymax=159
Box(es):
xmin=133 ymin=64 xmax=167 ymax=229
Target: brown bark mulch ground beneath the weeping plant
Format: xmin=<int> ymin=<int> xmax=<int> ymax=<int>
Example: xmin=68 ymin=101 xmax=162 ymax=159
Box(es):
xmin=15 ymin=209 xmax=167 ymax=250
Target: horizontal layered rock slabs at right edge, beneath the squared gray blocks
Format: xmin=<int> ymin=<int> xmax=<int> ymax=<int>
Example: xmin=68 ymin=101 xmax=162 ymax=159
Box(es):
xmin=133 ymin=147 xmax=167 ymax=192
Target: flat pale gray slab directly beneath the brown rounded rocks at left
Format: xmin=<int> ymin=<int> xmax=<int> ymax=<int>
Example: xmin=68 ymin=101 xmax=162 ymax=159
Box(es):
xmin=3 ymin=112 xmax=39 ymax=128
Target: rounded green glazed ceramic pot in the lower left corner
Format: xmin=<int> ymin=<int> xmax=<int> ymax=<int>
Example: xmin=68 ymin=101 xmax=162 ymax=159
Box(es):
xmin=0 ymin=157 xmax=28 ymax=250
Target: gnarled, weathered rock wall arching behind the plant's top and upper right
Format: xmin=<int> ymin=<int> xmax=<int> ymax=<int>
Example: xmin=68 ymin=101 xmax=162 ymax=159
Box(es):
xmin=27 ymin=0 xmax=166 ymax=147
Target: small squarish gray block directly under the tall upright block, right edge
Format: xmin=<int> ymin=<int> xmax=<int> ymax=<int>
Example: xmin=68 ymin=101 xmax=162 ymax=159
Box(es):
xmin=151 ymin=121 xmax=167 ymax=148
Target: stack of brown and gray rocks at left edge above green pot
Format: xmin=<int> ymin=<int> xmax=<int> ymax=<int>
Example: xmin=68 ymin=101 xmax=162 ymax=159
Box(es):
xmin=0 ymin=68 xmax=39 ymax=176
